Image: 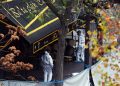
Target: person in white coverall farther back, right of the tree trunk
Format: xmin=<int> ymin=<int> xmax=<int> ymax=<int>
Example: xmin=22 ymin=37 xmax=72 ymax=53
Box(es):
xmin=76 ymin=31 xmax=85 ymax=61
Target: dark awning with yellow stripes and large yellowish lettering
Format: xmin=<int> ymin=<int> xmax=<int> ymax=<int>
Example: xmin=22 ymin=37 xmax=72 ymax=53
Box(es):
xmin=1 ymin=0 xmax=60 ymax=43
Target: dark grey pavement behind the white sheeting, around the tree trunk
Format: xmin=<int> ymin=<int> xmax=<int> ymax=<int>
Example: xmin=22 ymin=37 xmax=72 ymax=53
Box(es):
xmin=31 ymin=62 xmax=84 ymax=81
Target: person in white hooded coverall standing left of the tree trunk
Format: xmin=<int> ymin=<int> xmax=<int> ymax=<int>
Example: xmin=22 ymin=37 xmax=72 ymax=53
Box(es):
xmin=41 ymin=51 xmax=53 ymax=82
